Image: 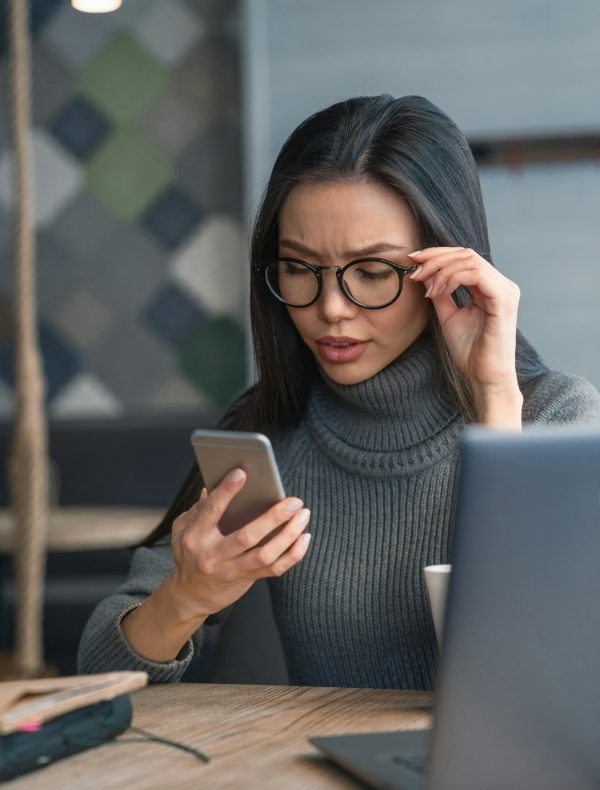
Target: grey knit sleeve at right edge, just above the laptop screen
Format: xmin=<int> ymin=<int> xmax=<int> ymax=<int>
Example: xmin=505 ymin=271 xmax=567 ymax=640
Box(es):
xmin=523 ymin=371 xmax=600 ymax=425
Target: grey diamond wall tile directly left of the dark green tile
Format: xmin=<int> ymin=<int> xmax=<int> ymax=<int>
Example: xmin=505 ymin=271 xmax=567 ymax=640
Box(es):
xmin=86 ymin=318 xmax=177 ymax=410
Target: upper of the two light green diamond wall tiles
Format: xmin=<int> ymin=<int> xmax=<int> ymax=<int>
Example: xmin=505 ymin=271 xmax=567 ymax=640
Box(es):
xmin=79 ymin=34 xmax=168 ymax=124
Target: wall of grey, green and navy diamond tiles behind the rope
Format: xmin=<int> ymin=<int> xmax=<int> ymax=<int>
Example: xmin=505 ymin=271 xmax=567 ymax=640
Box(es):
xmin=0 ymin=0 xmax=246 ymax=418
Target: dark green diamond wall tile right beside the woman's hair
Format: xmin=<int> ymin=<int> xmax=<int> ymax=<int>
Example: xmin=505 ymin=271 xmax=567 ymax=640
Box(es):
xmin=180 ymin=317 xmax=246 ymax=407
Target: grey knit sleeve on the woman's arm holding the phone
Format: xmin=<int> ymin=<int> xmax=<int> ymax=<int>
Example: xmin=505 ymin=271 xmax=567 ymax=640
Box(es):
xmin=77 ymin=546 xmax=202 ymax=683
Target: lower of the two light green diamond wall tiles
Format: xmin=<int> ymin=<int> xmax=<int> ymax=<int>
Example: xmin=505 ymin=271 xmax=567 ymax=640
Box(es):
xmin=87 ymin=130 xmax=173 ymax=221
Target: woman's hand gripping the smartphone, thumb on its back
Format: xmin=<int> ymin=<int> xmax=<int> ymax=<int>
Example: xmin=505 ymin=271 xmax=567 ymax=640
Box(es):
xmin=165 ymin=469 xmax=310 ymax=622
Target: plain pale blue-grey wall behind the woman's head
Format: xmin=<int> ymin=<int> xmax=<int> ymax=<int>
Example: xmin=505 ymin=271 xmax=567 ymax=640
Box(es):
xmin=244 ymin=0 xmax=600 ymax=387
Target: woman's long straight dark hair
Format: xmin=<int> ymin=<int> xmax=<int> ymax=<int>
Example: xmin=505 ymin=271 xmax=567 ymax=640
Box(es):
xmin=146 ymin=95 xmax=547 ymax=544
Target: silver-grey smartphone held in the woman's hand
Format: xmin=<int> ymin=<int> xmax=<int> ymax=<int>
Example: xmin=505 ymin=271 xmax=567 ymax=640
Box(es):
xmin=191 ymin=429 xmax=285 ymax=535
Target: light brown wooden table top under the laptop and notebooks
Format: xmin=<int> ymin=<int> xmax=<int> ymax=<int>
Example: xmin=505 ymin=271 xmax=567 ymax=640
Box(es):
xmin=4 ymin=683 xmax=431 ymax=790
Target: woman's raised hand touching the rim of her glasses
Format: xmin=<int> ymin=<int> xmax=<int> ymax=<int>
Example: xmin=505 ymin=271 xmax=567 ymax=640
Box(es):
xmin=409 ymin=247 xmax=520 ymax=391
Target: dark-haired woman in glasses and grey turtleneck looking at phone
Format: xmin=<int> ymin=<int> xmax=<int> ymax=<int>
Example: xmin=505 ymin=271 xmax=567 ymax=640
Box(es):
xmin=80 ymin=96 xmax=600 ymax=689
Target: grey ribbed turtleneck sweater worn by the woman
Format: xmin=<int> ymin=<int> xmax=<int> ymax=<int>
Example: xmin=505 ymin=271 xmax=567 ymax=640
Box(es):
xmin=79 ymin=342 xmax=600 ymax=689
